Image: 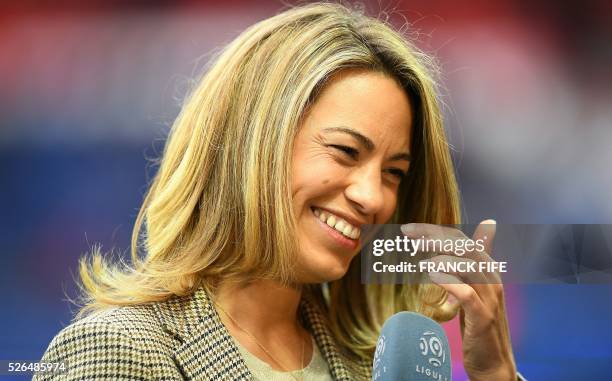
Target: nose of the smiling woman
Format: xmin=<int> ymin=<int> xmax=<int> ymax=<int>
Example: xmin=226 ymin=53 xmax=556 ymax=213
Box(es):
xmin=344 ymin=168 xmax=384 ymax=216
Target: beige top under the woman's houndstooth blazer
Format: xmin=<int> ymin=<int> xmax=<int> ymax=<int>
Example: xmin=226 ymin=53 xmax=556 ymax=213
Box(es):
xmin=234 ymin=339 xmax=333 ymax=381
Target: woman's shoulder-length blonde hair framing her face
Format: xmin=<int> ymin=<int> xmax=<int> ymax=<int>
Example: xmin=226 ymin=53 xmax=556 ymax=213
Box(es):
xmin=77 ymin=3 xmax=460 ymax=359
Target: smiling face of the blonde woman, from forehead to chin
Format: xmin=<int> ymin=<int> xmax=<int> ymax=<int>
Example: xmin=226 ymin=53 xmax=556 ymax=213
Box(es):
xmin=292 ymin=69 xmax=412 ymax=283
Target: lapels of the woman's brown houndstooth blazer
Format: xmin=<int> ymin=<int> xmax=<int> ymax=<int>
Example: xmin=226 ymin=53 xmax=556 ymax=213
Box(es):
xmin=154 ymin=288 xmax=352 ymax=381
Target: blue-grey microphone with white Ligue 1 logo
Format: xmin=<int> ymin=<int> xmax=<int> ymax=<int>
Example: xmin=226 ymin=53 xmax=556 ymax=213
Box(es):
xmin=372 ymin=312 xmax=452 ymax=381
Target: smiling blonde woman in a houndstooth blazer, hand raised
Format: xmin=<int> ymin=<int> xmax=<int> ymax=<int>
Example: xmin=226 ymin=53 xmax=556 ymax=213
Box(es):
xmin=35 ymin=4 xmax=516 ymax=381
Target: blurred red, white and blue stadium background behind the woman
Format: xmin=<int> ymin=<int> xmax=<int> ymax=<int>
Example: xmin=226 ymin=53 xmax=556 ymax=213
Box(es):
xmin=0 ymin=0 xmax=612 ymax=381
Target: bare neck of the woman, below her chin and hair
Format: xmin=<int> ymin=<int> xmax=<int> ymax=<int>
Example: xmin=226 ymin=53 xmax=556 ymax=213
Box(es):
xmin=215 ymin=280 xmax=302 ymax=337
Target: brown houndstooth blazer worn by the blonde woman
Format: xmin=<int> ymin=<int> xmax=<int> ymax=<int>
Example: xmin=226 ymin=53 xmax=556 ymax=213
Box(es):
xmin=33 ymin=289 xmax=371 ymax=381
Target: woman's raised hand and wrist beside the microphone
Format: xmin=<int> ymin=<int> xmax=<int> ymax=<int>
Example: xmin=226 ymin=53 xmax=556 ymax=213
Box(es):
xmin=402 ymin=220 xmax=516 ymax=381
